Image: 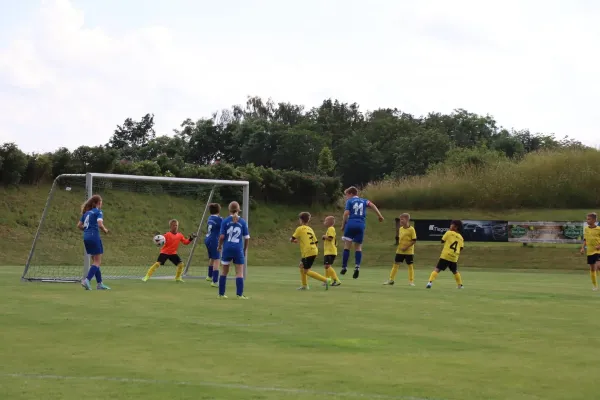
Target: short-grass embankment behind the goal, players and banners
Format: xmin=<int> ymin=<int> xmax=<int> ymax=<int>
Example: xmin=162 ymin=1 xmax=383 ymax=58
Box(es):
xmin=0 ymin=186 xmax=588 ymax=269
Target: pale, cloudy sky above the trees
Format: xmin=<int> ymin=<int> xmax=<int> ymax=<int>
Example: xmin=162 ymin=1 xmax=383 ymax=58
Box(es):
xmin=0 ymin=0 xmax=600 ymax=152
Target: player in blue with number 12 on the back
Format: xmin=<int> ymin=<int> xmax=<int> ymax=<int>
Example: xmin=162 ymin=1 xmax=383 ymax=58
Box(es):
xmin=218 ymin=201 xmax=250 ymax=299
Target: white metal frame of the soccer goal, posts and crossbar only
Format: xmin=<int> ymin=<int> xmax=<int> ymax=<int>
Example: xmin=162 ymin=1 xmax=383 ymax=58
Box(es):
xmin=21 ymin=172 xmax=250 ymax=282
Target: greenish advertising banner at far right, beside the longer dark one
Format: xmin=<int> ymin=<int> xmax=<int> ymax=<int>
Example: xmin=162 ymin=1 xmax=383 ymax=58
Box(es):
xmin=508 ymin=221 xmax=585 ymax=243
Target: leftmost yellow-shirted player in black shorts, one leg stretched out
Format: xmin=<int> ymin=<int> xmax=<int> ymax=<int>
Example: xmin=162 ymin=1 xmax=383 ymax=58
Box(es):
xmin=290 ymin=212 xmax=332 ymax=290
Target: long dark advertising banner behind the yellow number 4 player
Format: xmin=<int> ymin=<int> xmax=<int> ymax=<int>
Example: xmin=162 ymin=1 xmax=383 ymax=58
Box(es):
xmin=415 ymin=219 xmax=508 ymax=242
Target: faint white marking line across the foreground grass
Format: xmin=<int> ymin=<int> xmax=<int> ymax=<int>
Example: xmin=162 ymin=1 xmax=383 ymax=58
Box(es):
xmin=0 ymin=373 xmax=443 ymax=400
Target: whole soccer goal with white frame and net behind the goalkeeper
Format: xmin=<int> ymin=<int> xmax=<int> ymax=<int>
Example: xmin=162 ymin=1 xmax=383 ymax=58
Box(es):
xmin=22 ymin=173 xmax=250 ymax=282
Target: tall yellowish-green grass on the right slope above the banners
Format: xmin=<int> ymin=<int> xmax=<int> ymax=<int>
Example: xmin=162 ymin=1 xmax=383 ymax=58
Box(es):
xmin=363 ymin=149 xmax=600 ymax=210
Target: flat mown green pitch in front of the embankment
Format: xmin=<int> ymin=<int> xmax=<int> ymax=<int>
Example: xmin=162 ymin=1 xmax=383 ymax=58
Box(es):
xmin=0 ymin=266 xmax=600 ymax=400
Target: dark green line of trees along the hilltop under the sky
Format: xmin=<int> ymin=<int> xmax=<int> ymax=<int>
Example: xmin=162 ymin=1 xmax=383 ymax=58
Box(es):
xmin=0 ymin=97 xmax=585 ymax=205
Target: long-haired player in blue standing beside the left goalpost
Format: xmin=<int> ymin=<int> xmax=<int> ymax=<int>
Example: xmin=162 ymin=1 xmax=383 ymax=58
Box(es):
xmin=77 ymin=194 xmax=110 ymax=290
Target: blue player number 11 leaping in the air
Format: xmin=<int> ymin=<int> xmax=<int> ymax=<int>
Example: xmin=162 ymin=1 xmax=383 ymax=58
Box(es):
xmin=340 ymin=186 xmax=383 ymax=279
